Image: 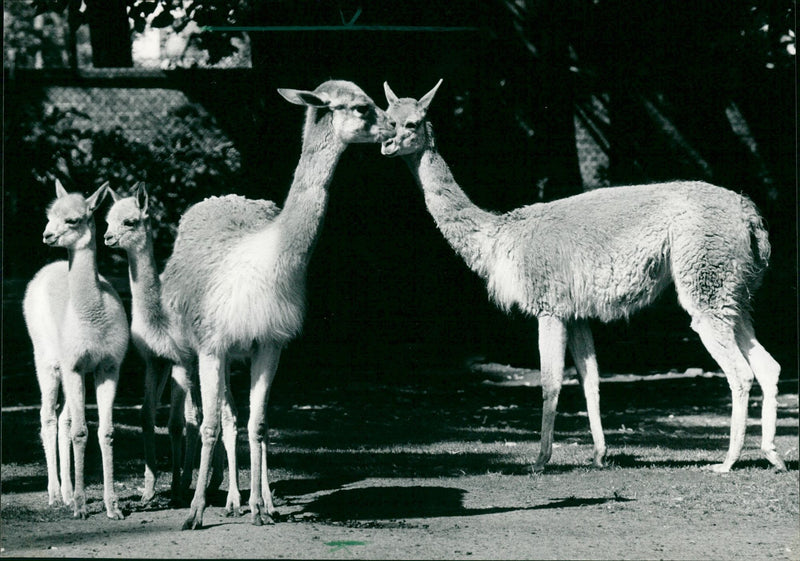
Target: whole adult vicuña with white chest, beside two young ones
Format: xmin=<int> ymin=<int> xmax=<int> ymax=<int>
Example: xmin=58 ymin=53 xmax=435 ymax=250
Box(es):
xmin=162 ymin=80 xmax=393 ymax=528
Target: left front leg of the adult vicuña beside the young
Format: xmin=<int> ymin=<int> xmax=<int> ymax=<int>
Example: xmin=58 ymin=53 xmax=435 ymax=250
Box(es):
xmin=183 ymin=353 xmax=225 ymax=530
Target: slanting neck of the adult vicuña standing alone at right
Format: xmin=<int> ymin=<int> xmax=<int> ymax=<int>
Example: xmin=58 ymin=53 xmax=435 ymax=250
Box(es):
xmin=404 ymin=123 xmax=499 ymax=275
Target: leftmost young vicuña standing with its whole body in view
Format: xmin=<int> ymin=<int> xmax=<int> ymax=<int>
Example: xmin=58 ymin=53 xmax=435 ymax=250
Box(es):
xmin=23 ymin=180 xmax=128 ymax=520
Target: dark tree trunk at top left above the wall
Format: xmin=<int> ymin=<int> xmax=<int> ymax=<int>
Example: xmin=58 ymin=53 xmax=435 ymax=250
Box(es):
xmin=86 ymin=0 xmax=133 ymax=68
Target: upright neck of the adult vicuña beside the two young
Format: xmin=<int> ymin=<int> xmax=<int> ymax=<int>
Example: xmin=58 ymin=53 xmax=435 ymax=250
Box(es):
xmin=276 ymin=108 xmax=347 ymax=265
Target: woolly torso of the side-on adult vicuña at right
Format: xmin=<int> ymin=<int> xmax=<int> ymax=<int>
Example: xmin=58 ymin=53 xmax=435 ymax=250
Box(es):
xmin=461 ymin=183 xmax=769 ymax=322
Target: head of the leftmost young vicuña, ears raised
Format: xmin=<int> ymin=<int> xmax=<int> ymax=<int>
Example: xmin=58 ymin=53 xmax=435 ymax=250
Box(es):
xmin=42 ymin=179 xmax=108 ymax=249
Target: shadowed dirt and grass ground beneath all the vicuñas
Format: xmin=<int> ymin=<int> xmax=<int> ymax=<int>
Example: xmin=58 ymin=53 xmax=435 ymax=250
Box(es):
xmin=0 ymin=366 xmax=800 ymax=559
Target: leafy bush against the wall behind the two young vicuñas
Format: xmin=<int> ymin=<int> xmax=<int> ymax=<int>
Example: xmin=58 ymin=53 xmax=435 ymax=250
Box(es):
xmin=24 ymin=104 xmax=241 ymax=271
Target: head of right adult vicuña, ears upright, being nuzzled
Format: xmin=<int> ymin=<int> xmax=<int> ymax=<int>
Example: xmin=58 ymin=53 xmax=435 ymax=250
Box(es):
xmin=381 ymin=80 xmax=442 ymax=157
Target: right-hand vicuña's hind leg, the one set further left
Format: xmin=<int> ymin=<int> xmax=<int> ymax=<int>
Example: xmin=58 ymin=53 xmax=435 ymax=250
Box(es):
xmin=692 ymin=316 xmax=753 ymax=473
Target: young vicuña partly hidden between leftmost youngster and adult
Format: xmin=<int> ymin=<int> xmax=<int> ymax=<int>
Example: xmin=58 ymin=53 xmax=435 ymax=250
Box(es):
xmin=105 ymin=183 xmax=236 ymax=513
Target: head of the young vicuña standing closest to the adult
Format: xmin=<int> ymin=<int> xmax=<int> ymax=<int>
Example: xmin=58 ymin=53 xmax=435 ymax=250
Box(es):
xmin=104 ymin=183 xmax=150 ymax=250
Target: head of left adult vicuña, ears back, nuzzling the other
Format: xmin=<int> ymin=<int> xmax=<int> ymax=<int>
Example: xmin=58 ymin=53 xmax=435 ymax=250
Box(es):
xmin=278 ymin=80 xmax=394 ymax=144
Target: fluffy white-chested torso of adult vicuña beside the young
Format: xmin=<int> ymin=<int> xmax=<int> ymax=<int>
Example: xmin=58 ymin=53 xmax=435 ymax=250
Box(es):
xmin=163 ymin=195 xmax=305 ymax=352
